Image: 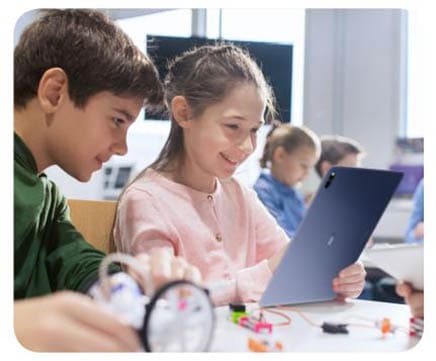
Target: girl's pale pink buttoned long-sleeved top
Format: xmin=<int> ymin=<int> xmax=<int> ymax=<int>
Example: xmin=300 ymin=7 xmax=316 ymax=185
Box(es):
xmin=114 ymin=169 xmax=289 ymax=305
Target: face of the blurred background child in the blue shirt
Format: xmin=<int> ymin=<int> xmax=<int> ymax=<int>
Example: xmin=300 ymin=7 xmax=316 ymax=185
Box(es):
xmin=271 ymin=146 xmax=317 ymax=187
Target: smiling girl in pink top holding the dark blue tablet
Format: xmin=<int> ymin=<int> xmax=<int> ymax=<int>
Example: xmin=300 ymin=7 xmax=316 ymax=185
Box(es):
xmin=114 ymin=45 xmax=365 ymax=305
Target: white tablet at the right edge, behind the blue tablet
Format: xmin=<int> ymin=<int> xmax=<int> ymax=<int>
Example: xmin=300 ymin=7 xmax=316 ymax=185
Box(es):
xmin=364 ymin=243 xmax=424 ymax=290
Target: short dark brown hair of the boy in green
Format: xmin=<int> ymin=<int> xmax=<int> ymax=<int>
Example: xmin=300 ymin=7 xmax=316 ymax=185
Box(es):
xmin=14 ymin=9 xmax=163 ymax=108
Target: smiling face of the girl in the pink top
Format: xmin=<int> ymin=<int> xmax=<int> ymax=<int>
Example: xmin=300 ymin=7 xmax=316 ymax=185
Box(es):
xmin=184 ymin=84 xmax=265 ymax=182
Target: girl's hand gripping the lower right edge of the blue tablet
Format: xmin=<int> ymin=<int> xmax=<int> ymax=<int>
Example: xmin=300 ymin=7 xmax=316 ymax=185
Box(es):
xmin=333 ymin=262 xmax=366 ymax=300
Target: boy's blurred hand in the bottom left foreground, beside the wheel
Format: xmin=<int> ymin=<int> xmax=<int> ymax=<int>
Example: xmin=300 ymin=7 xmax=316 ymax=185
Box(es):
xmin=14 ymin=291 xmax=141 ymax=352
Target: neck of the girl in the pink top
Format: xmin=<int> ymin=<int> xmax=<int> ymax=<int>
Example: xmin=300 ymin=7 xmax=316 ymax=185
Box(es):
xmin=162 ymin=159 xmax=217 ymax=193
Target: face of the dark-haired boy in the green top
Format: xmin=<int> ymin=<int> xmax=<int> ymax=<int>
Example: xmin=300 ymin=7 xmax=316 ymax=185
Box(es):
xmin=46 ymin=92 xmax=143 ymax=182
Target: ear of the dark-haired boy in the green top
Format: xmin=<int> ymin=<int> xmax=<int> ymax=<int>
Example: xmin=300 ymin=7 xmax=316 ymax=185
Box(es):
xmin=37 ymin=68 xmax=68 ymax=114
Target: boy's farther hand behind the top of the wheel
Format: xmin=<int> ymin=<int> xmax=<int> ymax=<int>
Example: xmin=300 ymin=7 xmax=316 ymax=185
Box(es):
xmin=129 ymin=248 xmax=202 ymax=290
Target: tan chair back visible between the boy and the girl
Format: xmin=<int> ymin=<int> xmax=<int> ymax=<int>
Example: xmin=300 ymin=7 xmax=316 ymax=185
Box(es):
xmin=68 ymin=199 xmax=117 ymax=253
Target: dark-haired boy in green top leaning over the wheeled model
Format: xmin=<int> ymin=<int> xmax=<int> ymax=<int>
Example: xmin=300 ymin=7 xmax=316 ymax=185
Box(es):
xmin=14 ymin=10 xmax=199 ymax=351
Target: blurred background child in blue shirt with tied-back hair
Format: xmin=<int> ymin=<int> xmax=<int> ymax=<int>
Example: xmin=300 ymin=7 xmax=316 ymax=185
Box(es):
xmin=254 ymin=124 xmax=320 ymax=238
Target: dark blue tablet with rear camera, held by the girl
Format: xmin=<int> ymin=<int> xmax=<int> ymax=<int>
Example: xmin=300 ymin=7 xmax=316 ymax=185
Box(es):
xmin=259 ymin=167 xmax=402 ymax=307
